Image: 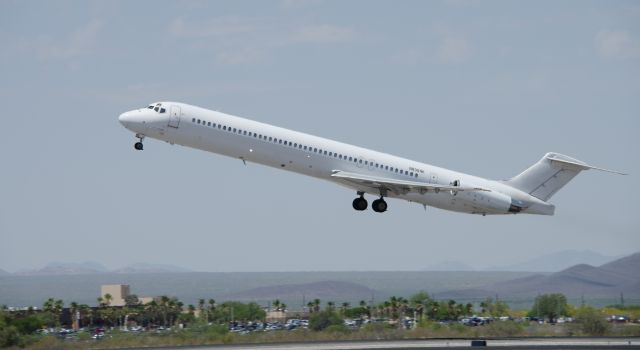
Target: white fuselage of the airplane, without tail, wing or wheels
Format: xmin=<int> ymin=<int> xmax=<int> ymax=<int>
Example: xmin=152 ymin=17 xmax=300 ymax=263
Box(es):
xmin=119 ymin=102 xmax=554 ymax=215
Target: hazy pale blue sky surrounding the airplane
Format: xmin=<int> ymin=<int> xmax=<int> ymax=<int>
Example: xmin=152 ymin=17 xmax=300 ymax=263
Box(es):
xmin=0 ymin=0 xmax=640 ymax=271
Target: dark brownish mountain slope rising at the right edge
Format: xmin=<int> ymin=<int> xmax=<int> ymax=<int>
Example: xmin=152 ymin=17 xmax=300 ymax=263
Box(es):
xmin=437 ymin=252 xmax=640 ymax=299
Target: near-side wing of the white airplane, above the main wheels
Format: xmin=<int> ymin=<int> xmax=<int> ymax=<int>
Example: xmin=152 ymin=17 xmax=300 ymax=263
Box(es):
xmin=331 ymin=170 xmax=490 ymax=195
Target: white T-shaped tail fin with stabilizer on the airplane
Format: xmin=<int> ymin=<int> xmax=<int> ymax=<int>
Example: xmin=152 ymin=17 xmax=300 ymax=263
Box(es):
xmin=504 ymin=152 xmax=627 ymax=202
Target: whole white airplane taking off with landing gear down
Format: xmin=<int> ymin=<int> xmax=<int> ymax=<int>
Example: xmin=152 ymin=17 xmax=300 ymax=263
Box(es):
xmin=119 ymin=102 xmax=625 ymax=215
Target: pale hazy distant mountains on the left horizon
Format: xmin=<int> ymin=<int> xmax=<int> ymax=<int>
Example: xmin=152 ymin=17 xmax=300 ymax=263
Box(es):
xmin=9 ymin=261 xmax=191 ymax=276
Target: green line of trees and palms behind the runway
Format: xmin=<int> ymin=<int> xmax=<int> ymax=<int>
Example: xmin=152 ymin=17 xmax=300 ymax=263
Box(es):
xmin=0 ymin=292 xmax=640 ymax=347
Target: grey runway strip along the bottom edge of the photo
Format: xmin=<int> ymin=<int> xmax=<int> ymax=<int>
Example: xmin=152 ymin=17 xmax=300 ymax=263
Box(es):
xmin=140 ymin=337 xmax=640 ymax=350
